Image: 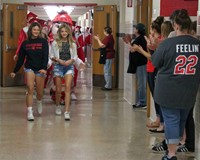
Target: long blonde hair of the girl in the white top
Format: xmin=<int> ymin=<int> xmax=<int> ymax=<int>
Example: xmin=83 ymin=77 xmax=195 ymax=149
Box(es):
xmin=56 ymin=24 xmax=74 ymax=48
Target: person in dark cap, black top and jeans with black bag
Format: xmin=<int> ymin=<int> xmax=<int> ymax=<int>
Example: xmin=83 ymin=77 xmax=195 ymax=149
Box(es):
xmin=127 ymin=23 xmax=147 ymax=109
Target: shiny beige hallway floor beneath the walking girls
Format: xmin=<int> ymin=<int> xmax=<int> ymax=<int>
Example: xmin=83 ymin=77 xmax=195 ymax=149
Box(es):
xmin=0 ymin=69 xmax=194 ymax=160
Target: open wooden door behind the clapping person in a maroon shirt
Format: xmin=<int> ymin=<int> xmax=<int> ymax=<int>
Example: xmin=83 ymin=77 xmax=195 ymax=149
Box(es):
xmin=92 ymin=5 xmax=118 ymax=88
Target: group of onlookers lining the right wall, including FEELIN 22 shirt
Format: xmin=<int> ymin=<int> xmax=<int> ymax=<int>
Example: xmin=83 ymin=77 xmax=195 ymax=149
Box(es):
xmin=128 ymin=9 xmax=200 ymax=160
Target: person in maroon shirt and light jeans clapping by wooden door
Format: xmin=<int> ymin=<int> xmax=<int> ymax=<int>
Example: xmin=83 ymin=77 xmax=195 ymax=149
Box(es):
xmin=94 ymin=27 xmax=115 ymax=90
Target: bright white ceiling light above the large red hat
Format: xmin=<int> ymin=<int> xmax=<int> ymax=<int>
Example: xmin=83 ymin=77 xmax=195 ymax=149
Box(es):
xmin=44 ymin=6 xmax=74 ymax=20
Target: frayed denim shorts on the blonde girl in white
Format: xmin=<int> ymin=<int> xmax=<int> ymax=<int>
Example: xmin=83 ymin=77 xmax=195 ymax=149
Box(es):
xmin=53 ymin=64 xmax=74 ymax=77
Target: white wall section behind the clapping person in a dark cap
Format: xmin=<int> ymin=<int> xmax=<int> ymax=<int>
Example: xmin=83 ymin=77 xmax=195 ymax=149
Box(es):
xmin=119 ymin=0 xmax=137 ymax=104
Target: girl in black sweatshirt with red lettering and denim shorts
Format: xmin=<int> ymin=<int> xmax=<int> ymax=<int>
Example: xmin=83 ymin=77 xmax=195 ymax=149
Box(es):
xmin=10 ymin=22 xmax=49 ymax=121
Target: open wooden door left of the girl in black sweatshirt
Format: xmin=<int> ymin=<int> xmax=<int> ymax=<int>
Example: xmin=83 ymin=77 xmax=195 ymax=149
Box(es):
xmin=1 ymin=4 xmax=27 ymax=87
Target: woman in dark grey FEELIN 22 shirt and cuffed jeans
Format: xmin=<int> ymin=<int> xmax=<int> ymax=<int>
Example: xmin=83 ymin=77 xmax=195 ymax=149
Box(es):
xmin=152 ymin=9 xmax=200 ymax=160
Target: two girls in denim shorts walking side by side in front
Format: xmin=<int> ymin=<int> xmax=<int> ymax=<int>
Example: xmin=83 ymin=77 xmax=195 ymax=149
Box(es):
xmin=10 ymin=11 xmax=85 ymax=121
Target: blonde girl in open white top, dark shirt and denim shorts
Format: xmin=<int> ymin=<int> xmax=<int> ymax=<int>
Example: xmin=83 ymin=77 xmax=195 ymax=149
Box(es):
xmin=51 ymin=24 xmax=77 ymax=120
